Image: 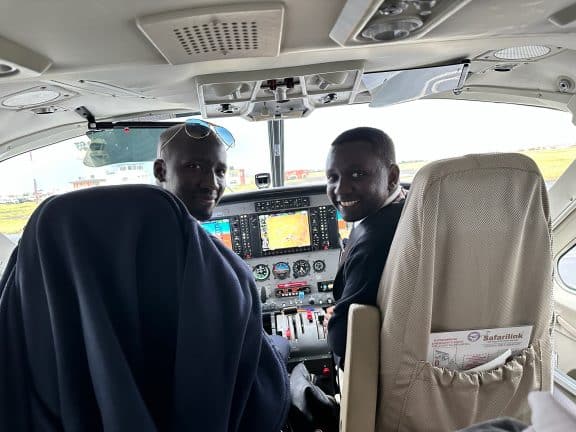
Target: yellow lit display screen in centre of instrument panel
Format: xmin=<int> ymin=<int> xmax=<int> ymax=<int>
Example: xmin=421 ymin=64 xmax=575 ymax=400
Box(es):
xmin=258 ymin=210 xmax=311 ymax=251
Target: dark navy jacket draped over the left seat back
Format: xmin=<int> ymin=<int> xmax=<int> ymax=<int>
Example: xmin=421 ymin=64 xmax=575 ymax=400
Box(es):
xmin=0 ymin=186 xmax=289 ymax=432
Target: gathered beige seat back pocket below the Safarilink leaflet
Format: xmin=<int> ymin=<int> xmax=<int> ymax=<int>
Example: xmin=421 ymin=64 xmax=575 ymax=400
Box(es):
xmin=397 ymin=346 xmax=542 ymax=431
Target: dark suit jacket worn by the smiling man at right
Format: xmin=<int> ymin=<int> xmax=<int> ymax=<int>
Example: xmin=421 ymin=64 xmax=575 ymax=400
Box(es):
xmin=328 ymin=200 xmax=404 ymax=367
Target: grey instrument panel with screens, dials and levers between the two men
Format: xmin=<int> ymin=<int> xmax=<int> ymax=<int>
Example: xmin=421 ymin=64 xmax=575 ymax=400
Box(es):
xmin=202 ymin=186 xmax=349 ymax=369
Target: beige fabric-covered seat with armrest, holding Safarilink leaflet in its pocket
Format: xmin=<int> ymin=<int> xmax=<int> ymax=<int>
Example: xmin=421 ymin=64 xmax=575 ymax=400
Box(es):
xmin=341 ymin=154 xmax=553 ymax=432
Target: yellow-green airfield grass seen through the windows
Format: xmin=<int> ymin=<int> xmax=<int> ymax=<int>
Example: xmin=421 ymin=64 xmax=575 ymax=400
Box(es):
xmin=0 ymin=146 xmax=576 ymax=238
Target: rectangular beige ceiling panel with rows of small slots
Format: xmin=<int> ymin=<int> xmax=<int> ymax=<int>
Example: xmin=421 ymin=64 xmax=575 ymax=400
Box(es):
xmin=137 ymin=3 xmax=284 ymax=64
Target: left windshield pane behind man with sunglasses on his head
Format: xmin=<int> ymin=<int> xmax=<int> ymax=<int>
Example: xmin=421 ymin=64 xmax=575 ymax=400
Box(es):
xmin=0 ymin=118 xmax=270 ymax=242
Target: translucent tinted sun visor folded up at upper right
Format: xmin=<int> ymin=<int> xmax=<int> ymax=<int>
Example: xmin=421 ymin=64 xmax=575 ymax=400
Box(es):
xmin=362 ymin=63 xmax=468 ymax=107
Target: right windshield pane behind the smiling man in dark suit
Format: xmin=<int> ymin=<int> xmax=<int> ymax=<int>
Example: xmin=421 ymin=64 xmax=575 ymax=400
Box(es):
xmin=284 ymin=100 xmax=576 ymax=187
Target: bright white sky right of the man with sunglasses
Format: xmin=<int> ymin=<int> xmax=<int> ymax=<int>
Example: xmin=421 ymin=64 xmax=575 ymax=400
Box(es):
xmin=221 ymin=100 xmax=576 ymax=170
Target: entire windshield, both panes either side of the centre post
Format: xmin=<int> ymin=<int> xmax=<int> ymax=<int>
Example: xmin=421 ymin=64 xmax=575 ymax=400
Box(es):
xmin=0 ymin=100 xmax=576 ymax=245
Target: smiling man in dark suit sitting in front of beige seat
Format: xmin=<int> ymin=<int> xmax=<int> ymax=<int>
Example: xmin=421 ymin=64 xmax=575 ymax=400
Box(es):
xmin=325 ymin=127 xmax=405 ymax=368
